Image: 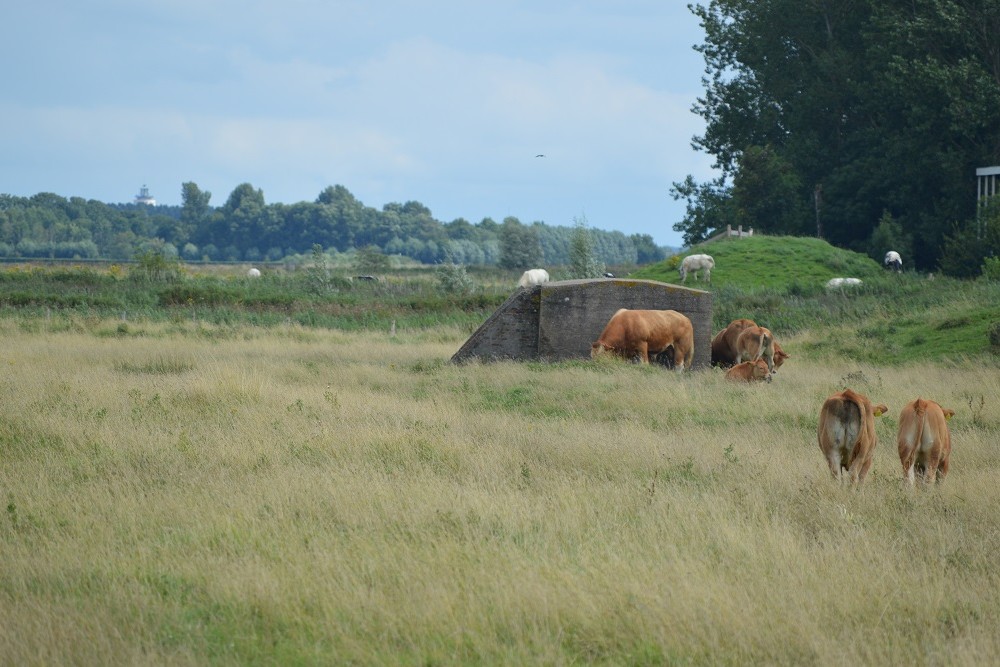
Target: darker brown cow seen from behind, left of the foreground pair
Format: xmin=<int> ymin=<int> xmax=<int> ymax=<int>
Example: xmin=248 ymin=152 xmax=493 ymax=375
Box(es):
xmin=819 ymin=389 xmax=889 ymax=484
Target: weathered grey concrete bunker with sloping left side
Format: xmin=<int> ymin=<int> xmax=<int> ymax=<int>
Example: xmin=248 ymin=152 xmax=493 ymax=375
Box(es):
xmin=452 ymin=278 xmax=712 ymax=369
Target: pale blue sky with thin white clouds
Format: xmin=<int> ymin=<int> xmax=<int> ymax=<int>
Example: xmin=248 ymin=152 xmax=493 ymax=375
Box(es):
xmin=0 ymin=0 xmax=714 ymax=247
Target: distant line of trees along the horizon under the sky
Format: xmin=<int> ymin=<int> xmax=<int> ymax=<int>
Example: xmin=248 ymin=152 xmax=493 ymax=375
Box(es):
xmin=0 ymin=182 xmax=667 ymax=268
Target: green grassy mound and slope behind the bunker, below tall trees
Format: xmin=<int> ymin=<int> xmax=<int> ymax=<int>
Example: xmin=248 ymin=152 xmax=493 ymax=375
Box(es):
xmin=629 ymin=236 xmax=1000 ymax=365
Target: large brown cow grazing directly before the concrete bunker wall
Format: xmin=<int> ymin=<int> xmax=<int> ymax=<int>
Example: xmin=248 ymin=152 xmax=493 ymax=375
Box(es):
xmin=590 ymin=308 xmax=694 ymax=371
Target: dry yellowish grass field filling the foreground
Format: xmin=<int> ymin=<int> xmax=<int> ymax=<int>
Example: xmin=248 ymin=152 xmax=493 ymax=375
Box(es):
xmin=0 ymin=319 xmax=1000 ymax=665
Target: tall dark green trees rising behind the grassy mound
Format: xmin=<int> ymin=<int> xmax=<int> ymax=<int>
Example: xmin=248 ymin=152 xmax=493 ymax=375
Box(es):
xmin=672 ymin=0 xmax=1000 ymax=269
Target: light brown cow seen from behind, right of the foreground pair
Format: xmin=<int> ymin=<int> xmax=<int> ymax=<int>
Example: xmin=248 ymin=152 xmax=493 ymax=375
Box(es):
xmin=898 ymin=398 xmax=955 ymax=485
